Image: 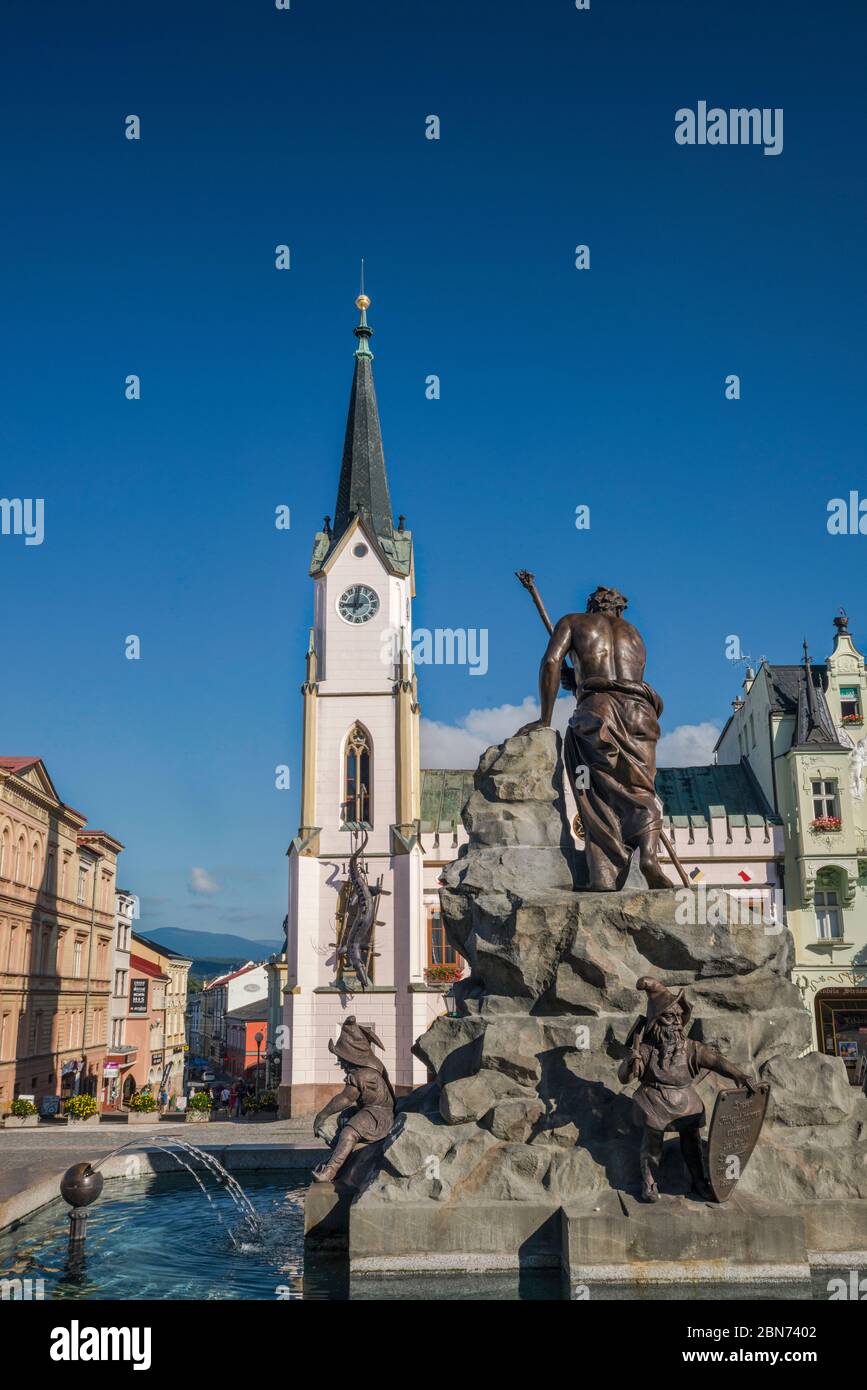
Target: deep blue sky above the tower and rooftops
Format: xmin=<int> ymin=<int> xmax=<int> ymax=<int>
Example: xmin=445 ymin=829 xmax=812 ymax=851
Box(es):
xmin=0 ymin=0 xmax=867 ymax=938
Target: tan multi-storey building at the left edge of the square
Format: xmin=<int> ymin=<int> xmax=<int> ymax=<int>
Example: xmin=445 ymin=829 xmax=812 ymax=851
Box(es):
xmin=0 ymin=758 xmax=124 ymax=1112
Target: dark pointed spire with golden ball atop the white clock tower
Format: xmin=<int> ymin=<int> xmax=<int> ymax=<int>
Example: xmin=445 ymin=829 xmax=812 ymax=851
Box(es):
xmin=332 ymin=278 xmax=395 ymax=545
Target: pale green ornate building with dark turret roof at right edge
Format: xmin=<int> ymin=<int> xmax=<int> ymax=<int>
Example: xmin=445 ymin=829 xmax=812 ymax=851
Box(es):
xmin=717 ymin=614 xmax=867 ymax=1083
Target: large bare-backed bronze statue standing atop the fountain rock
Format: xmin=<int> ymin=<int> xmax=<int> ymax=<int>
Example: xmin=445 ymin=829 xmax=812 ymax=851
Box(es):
xmin=518 ymin=583 xmax=671 ymax=892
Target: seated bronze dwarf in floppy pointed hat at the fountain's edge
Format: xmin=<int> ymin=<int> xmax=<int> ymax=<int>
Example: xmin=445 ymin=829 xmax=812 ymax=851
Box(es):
xmin=313 ymin=1017 xmax=395 ymax=1183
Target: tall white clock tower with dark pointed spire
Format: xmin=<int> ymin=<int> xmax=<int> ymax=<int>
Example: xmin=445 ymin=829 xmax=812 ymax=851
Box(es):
xmin=281 ymin=293 xmax=428 ymax=1115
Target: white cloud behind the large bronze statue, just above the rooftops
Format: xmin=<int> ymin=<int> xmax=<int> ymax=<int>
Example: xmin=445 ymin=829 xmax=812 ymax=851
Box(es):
xmin=421 ymin=695 xmax=720 ymax=769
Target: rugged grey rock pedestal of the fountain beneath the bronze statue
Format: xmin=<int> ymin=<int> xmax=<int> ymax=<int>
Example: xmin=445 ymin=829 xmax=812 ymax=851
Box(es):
xmin=323 ymin=730 xmax=867 ymax=1270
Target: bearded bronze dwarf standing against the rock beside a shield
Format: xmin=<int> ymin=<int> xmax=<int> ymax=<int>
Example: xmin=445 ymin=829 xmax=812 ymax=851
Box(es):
xmin=617 ymin=976 xmax=756 ymax=1202
